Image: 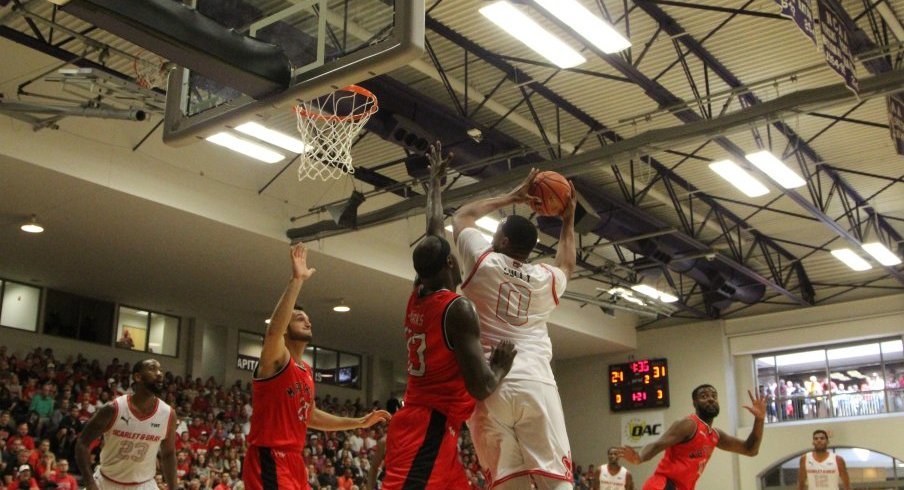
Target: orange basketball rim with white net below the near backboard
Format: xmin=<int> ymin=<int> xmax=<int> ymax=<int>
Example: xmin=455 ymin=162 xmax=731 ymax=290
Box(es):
xmin=295 ymin=85 xmax=379 ymax=180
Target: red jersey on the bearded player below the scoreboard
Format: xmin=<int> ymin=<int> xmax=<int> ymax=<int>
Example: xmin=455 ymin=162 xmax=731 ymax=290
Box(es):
xmin=654 ymin=415 xmax=719 ymax=490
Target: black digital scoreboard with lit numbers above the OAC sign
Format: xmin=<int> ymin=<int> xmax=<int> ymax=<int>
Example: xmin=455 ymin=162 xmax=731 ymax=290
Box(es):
xmin=609 ymin=359 xmax=669 ymax=412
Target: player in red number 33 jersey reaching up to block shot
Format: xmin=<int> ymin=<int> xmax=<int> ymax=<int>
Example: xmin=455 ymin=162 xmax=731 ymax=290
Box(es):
xmin=382 ymin=142 xmax=515 ymax=490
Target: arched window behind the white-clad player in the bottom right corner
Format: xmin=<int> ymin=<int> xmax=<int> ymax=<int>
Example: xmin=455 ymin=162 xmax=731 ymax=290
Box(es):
xmin=760 ymin=447 xmax=904 ymax=490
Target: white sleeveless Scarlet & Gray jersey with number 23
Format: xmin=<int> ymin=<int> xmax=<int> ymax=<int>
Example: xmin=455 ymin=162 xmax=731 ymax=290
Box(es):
xmin=98 ymin=395 xmax=172 ymax=485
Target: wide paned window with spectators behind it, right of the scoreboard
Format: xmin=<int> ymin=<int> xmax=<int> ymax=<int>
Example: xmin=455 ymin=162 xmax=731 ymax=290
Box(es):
xmin=754 ymin=339 xmax=904 ymax=423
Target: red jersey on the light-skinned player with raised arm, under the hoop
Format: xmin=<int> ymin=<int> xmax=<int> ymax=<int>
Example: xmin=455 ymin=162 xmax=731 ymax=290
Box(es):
xmin=248 ymin=359 xmax=314 ymax=453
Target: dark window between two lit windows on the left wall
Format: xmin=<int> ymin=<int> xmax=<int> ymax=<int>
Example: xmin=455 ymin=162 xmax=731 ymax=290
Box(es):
xmin=44 ymin=289 xmax=116 ymax=345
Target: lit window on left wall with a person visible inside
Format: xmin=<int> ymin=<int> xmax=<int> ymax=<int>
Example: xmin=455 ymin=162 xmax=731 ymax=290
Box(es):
xmin=116 ymin=306 xmax=179 ymax=357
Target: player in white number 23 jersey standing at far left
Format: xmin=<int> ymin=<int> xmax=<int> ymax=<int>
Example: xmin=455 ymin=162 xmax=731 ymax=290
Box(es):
xmin=75 ymin=359 xmax=177 ymax=490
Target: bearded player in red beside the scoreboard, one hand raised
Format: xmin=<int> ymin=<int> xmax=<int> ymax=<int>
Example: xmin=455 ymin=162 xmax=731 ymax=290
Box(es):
xmin=622 ymin=384 xmax=766 ymax=490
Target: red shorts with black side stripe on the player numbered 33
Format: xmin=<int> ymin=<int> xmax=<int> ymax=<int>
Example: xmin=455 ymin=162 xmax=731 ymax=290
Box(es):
xmin=382 ymin=406 xmax=469 ymax=490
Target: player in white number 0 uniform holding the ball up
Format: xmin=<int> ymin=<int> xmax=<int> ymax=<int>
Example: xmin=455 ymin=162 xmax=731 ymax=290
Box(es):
xmin=452 ymin=169 xmax=577 ymax=490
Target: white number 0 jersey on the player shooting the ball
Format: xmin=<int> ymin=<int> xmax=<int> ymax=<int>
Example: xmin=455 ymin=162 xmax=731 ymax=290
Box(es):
xmin=456 ymin=228 xmax=566 ymax=384
